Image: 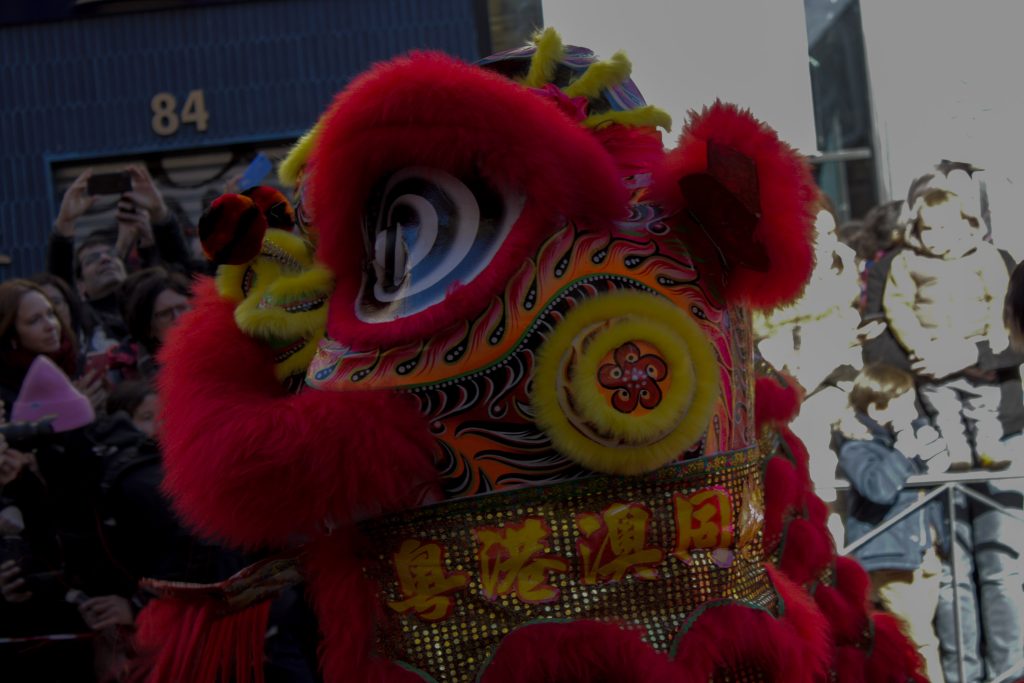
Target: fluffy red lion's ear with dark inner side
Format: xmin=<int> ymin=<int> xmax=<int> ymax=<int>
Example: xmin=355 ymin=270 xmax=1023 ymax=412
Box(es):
xmin=657 ymin=102 xmax=817 ymax=308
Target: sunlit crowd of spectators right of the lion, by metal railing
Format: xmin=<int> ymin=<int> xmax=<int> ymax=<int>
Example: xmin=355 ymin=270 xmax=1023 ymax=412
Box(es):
xmin=757 ymin=161 xmax=1024 ymax=683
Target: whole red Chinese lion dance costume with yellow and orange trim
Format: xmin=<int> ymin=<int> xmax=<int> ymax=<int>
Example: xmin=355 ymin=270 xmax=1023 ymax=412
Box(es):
xmin=146 ymin=30 xmax=923 ymax=683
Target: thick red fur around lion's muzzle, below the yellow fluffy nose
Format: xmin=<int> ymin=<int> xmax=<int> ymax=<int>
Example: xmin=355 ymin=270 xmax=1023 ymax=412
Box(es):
xmin=160 ymin=282 xmax=436 ymax=546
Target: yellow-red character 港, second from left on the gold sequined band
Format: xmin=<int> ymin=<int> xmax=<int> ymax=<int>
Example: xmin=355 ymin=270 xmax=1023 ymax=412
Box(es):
xmin=474 ymin=517 xmax=568 ymax=602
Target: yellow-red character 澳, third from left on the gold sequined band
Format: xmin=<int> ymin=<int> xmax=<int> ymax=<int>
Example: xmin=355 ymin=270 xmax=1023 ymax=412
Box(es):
xmin=577 ymin=503 xmax=665 ymax=584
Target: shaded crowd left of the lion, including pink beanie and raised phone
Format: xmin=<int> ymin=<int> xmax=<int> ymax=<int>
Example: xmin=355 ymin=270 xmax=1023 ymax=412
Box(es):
xmin=0 ymin=166 xmax=317 ymax=682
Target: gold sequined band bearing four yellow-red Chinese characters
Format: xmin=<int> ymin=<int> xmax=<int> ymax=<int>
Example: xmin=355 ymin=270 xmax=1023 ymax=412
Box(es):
xmin=362 ymin=449 xmax=777 ymax=682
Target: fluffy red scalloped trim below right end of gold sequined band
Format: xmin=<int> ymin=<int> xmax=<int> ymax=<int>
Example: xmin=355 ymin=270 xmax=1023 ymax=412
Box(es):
xmin=676 ymin=565 xmax=831 ymax=683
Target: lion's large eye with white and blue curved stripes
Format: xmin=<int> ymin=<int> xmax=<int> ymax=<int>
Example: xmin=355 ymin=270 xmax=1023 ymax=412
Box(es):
xmin=356 ymin=167 xmax=523 ymax=323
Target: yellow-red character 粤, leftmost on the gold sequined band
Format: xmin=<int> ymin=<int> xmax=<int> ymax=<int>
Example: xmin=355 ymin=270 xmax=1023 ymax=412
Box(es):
xmin=388 ymin=539 xmax=469 ymax=622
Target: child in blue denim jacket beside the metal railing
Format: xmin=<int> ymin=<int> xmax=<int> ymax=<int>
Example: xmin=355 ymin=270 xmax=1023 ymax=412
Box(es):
xmin=839 ymin=364 xmax=945 ymax=681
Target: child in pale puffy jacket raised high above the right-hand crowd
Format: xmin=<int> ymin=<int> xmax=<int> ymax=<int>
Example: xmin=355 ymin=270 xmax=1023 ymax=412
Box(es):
xmin=884 ymin=165 xmax=1009 ymax=470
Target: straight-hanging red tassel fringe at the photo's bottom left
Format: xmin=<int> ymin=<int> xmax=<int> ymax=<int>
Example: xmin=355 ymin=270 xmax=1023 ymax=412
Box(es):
xmin=131 ymin=599 xmax=270 ymax=683
